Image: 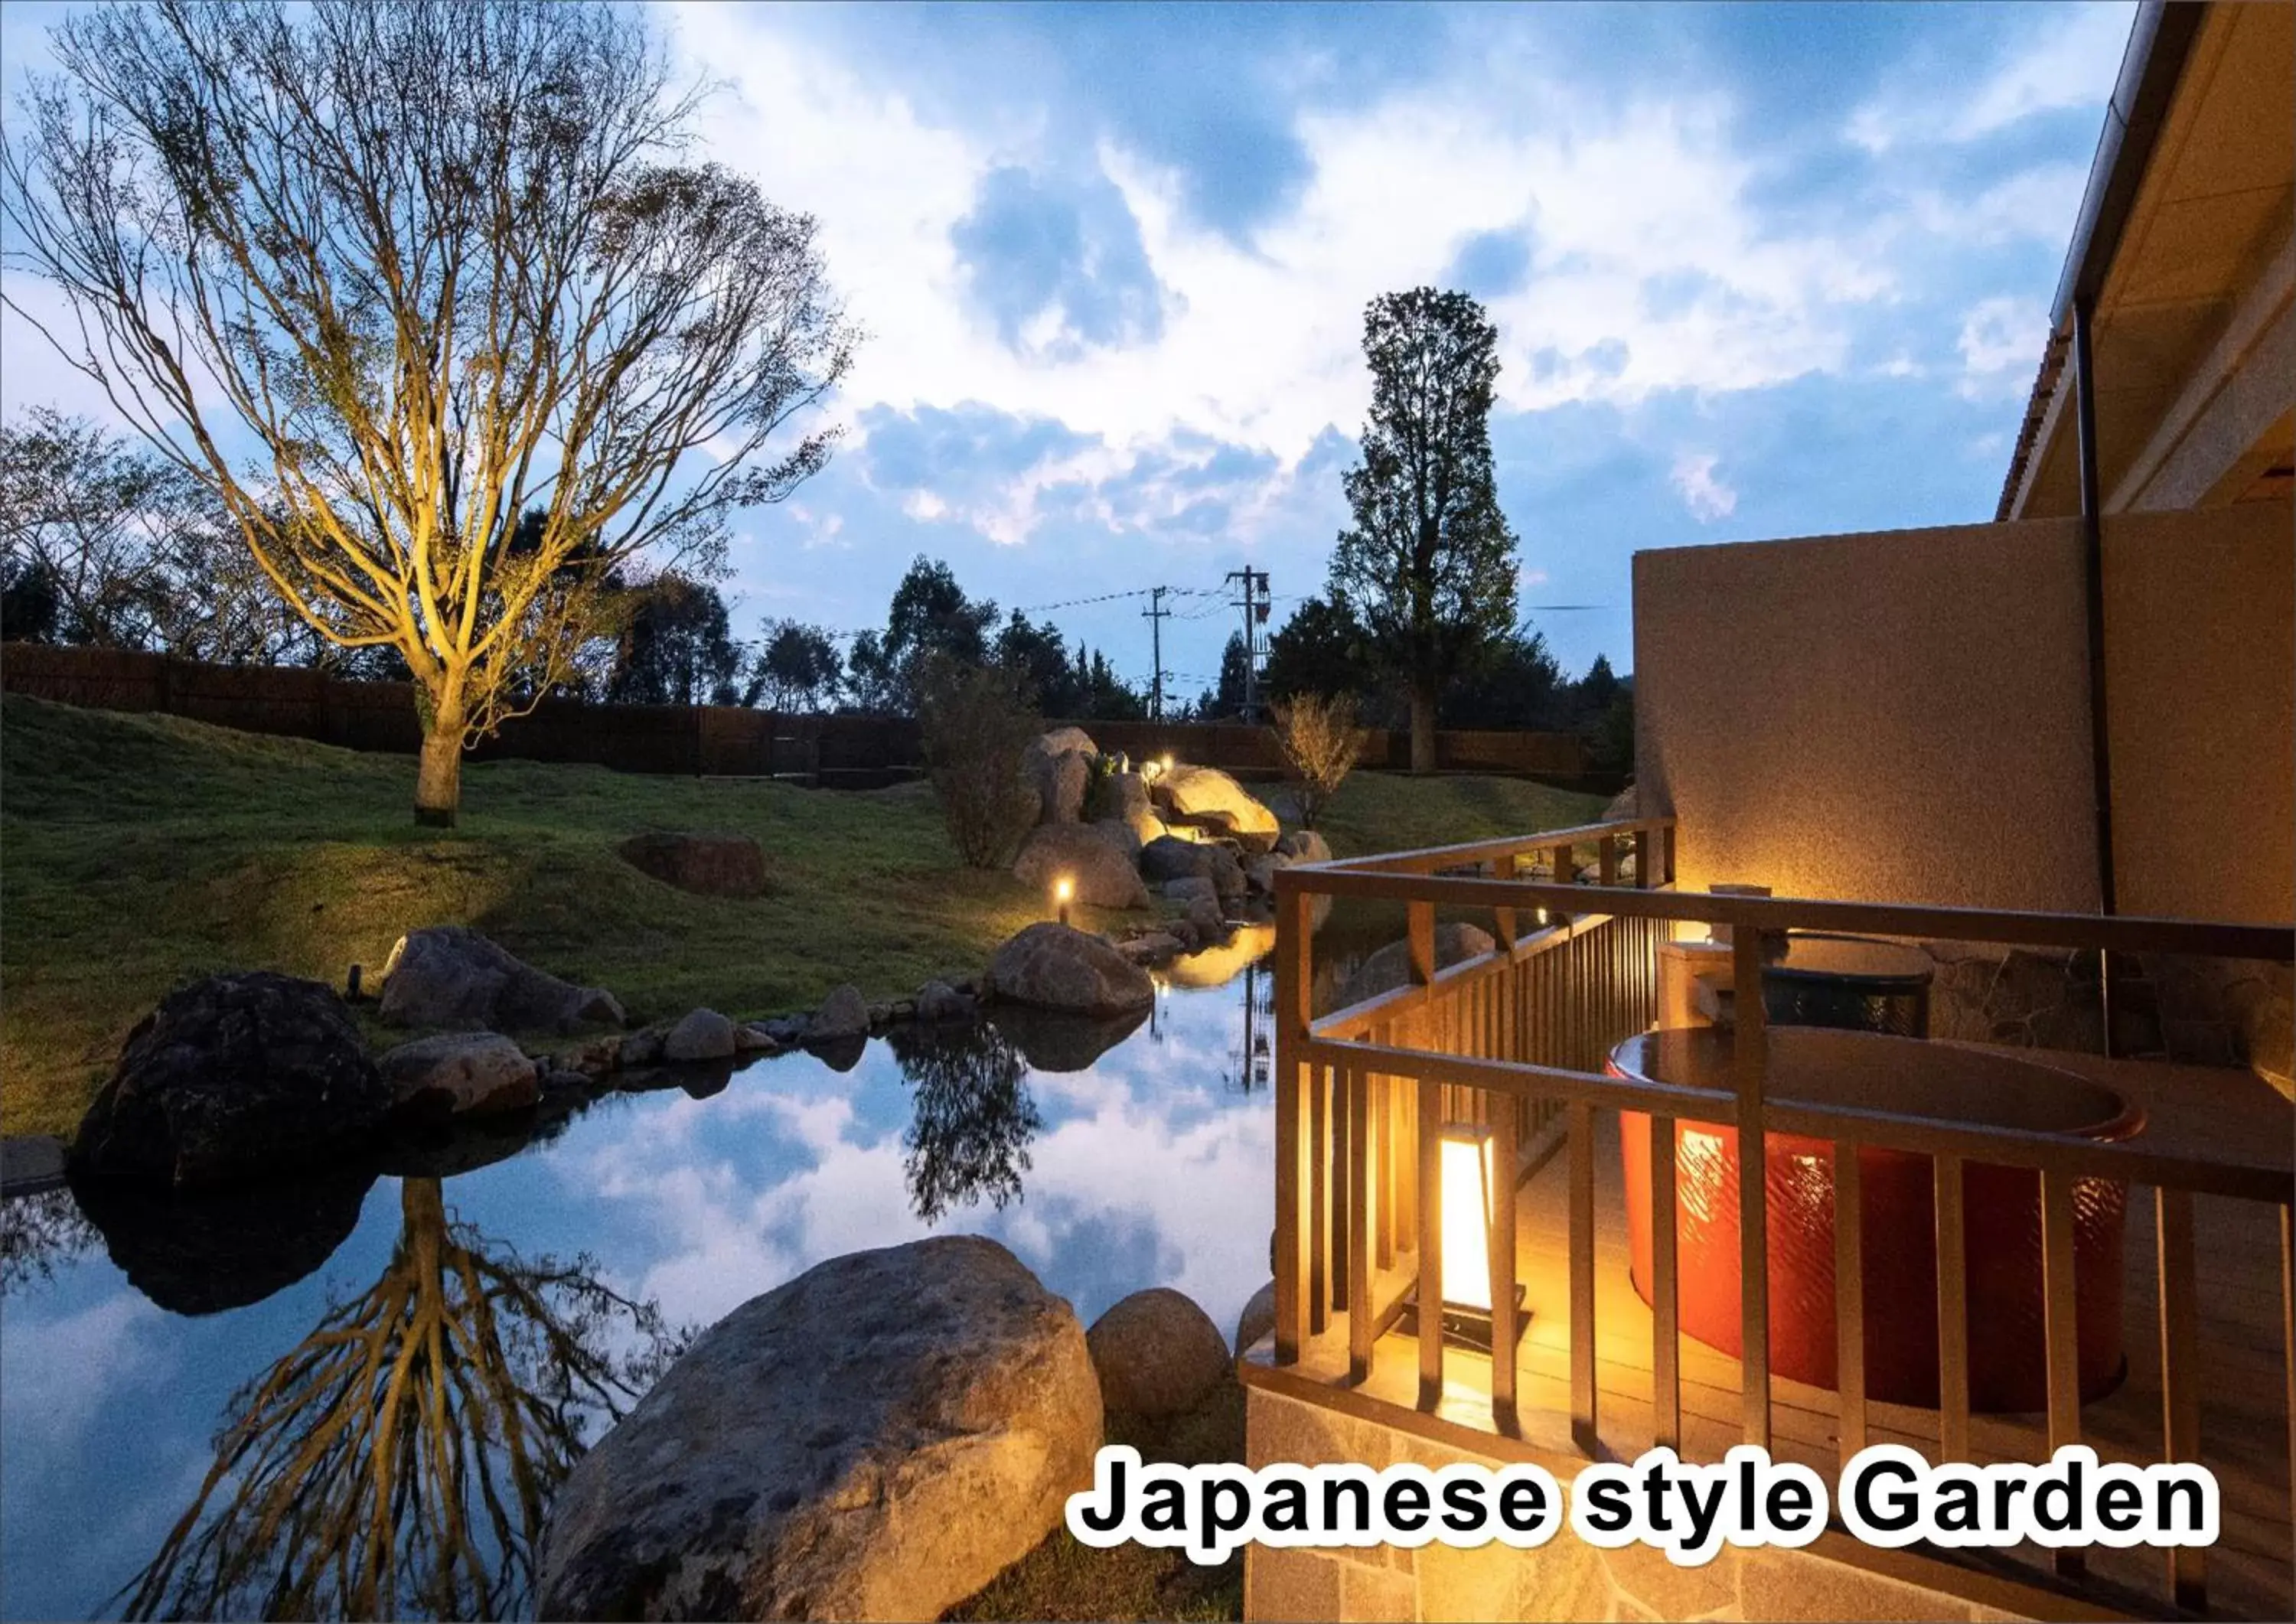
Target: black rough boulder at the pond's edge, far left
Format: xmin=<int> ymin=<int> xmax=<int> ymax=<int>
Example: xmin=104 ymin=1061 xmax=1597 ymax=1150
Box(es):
xmin=73 ymin=970 xmax=393 ymax=1188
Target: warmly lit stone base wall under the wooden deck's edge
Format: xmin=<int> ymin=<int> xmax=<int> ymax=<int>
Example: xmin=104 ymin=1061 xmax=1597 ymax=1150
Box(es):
xmin=1244 ymin=1388 xmax=2018 ymax=1624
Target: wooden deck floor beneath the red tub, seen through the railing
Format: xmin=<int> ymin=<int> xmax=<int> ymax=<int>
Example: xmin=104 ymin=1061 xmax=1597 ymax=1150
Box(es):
xmin=1263 ymin=1055 xmax=2296 ymax=1619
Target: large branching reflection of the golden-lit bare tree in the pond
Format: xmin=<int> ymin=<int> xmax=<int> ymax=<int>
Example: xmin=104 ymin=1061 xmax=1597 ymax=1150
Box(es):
xmin=124 ymin=1179 xmax=675 ymax=1619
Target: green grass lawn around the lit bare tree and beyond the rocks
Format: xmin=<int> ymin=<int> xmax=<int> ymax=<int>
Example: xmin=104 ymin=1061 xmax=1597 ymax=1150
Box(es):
xmin=0 ymin=696 xmax=1600 ymax=1135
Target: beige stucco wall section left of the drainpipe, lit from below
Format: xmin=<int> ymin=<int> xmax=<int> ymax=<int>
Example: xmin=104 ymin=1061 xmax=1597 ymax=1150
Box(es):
xmin=1635 ymin=519 xmax=2096 ymax=910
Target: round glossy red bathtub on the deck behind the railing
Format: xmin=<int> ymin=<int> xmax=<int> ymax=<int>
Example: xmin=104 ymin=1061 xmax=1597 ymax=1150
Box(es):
xmin=1609 ymin=1027 xmax=2144 ymax=1410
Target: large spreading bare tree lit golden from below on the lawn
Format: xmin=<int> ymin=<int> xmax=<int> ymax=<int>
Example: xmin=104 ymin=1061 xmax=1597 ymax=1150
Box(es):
xmin=0 ymin=0 xmax=854 ymax=823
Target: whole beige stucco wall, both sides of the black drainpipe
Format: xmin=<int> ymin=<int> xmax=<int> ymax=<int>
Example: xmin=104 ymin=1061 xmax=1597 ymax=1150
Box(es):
xmin=1635 ymin=503 xmax=2296 ymax=924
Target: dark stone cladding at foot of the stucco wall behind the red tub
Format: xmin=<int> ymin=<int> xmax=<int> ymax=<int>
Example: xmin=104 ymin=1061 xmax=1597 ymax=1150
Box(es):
xmin=1926 ymin=942 xmax=2296 ymax=1094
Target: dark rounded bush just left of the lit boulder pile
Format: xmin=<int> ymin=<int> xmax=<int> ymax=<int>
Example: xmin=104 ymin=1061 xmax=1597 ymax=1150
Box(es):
xmin=916 ymin=654 xmax=1045 ymax=869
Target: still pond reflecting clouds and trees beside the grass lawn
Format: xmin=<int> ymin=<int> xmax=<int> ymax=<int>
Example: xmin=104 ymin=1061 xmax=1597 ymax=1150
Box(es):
xmin=0 ymin=931 xmax=1332 ymax=1617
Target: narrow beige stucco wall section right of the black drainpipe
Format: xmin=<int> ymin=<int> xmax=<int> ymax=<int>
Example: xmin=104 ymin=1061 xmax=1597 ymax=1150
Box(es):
xmin=2105 ymin=503 xmax=2296 ymax=924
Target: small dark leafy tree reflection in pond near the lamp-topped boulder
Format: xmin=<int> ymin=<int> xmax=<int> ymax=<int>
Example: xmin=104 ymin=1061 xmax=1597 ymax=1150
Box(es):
xmin=889 ymin=1020 xmax=1045 ymax=1225
